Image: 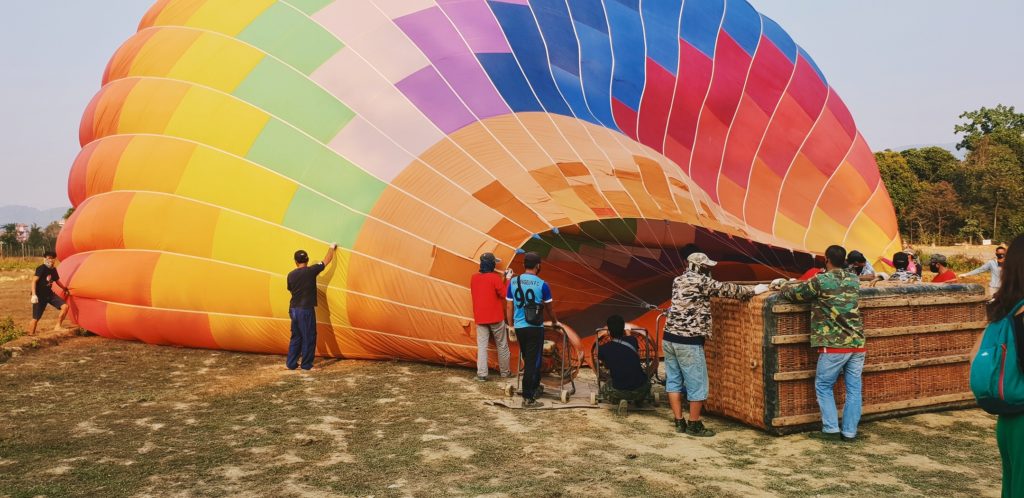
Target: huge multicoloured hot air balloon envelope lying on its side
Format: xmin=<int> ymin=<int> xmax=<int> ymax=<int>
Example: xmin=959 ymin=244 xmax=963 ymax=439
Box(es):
xmin=58 ymin=0 xmax=900 ymax=364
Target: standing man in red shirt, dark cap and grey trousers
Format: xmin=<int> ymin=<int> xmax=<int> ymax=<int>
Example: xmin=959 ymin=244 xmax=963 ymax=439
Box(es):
xmin=469 ymin=252 xmax=511 ymax=382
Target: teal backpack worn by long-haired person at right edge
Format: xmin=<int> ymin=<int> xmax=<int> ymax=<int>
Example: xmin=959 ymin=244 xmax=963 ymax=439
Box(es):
xmin=971 ymin=301 xmax=1024 ymax=415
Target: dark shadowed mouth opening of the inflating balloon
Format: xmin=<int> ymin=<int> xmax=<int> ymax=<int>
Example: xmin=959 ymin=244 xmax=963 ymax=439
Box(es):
xmin=508 ymin=218 xmax=814 ymax=337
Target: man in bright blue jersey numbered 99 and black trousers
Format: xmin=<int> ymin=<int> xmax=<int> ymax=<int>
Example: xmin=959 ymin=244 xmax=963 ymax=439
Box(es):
xmin=505 ymin=252 xmax=558 ymax=408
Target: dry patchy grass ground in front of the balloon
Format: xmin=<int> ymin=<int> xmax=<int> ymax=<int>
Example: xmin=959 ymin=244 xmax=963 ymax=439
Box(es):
xmin=0 ymin=262 xmax=999 ymax=497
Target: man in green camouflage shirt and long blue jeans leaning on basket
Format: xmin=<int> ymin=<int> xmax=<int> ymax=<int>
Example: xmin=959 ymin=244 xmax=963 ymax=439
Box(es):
xmin=780 ymin=242 xmax=866 ymax=441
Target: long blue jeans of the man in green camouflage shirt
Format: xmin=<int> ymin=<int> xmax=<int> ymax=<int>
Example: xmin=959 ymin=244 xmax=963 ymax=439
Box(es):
xmin=814 ymin=352 xmax=864 ymax=438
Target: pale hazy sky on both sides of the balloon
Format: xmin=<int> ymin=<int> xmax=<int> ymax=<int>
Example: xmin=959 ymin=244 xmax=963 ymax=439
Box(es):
xmin=0 ymin=0 xmax=1024 ymax=209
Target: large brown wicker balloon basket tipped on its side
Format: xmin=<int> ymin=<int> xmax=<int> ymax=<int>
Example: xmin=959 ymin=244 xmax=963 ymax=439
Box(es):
xmin=706 ymin=284 xmax=987 ymax=434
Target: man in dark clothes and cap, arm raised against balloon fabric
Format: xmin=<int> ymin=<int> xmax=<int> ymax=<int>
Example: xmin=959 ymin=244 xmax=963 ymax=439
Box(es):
xmin=285 ymin=244 xmax=338 ymax=370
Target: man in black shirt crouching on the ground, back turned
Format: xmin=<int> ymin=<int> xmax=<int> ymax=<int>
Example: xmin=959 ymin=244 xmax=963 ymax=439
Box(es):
xmin=597 ymin=315 xmax=650 ymax=413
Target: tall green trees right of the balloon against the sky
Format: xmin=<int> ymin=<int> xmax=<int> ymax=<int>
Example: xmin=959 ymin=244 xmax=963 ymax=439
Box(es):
xmin=874 ymin=105 xmax=1024 ymax=245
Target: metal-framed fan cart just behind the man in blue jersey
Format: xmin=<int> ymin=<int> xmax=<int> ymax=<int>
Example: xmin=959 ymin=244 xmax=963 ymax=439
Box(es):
xmin=505 ymin=324 xmax=581 ymax=403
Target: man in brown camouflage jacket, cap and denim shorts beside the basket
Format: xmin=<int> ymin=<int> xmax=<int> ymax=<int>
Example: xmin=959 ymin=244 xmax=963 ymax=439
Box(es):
xmin=662 ymin=252 xmax=768 ymax=437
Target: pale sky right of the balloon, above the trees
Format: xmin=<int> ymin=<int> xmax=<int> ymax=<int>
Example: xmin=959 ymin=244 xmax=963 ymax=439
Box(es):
xmin=750 ymin=0 xmax=1024 ymax=151
